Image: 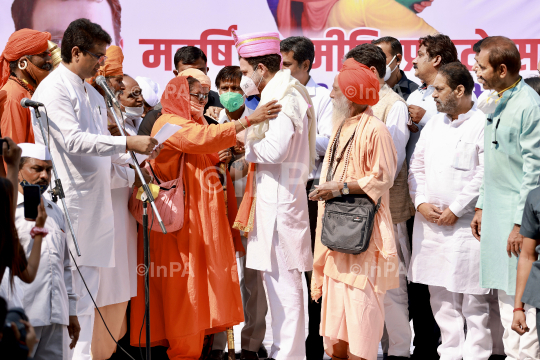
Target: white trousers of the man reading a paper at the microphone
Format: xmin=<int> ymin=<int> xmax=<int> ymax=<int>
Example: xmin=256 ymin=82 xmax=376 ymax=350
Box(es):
xmin=71 ymin=266 xmax=101 ymax=360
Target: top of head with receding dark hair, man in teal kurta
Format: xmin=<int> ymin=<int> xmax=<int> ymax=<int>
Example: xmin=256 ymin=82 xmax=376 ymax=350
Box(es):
xmin=480 ymin=36 xmax=521 ymax=75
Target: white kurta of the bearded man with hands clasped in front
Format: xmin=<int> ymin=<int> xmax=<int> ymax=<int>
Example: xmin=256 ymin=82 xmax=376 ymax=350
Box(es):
xmin=408 ymin=105 xmax=489 ymax=295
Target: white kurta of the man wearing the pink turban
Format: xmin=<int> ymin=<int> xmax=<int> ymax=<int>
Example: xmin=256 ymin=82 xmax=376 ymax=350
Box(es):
xmin=246 ymin=112 xmax=313 ymax=271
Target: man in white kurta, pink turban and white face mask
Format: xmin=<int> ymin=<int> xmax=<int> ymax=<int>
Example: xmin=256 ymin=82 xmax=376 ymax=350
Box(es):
xmin=235 ymin=33 xmax=316 ymax=360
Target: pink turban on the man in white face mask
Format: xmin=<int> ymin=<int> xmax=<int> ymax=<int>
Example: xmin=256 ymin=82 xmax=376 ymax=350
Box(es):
xmin=232 ymin=30 xmax=281 ymax=58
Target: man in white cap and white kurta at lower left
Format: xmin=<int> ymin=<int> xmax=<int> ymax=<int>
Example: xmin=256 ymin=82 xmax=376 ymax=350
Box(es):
xmin=15 ymin=143 xmax=79 ymax=360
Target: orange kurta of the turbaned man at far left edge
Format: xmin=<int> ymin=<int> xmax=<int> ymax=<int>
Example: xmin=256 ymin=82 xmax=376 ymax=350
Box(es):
xmin=0 ymin=79 xmax=34 ymax=144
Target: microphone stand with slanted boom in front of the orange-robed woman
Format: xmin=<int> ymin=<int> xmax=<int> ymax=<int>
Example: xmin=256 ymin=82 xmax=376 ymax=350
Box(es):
xmin=105 ymin=95 xmax=167 ymax=360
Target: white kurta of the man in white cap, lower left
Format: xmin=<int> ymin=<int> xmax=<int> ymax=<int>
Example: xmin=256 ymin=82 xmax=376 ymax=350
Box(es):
xmin=15 ymin=193 xmax=79 ymax=326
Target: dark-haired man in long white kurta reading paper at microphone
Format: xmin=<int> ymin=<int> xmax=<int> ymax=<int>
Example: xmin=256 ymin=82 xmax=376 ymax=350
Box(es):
xmin=32 ymin=19 xmax=158 ymax=360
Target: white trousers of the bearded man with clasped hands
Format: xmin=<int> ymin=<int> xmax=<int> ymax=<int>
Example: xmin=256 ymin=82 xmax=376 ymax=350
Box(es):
xmin=429 ymin=286 xmax=493 ymax=360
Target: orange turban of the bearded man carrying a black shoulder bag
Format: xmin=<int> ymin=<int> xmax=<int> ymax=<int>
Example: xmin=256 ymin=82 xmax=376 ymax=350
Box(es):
xmin=338 ymin=58 xmax=380 ymax=106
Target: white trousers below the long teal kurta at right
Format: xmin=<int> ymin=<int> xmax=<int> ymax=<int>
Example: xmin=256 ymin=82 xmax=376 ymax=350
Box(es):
xmin=499 ymin=290 xmax=540 ymax=360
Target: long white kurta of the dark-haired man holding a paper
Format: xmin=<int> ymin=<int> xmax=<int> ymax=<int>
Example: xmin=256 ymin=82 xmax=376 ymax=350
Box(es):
xmin=32 ymin=64 xmax=129 ymax=267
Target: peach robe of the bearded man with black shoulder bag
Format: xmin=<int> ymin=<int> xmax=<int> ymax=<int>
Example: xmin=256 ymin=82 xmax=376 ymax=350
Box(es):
xmin=311 ymin=108 xmax=399 ymax=299
